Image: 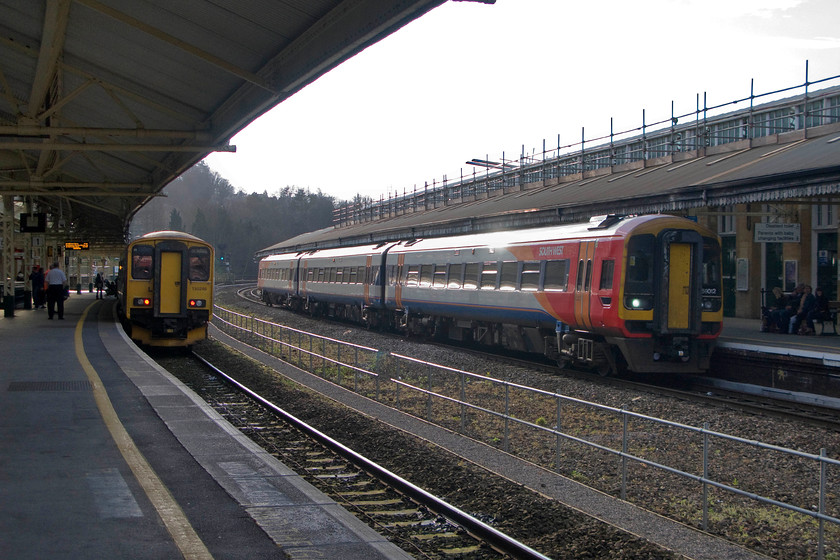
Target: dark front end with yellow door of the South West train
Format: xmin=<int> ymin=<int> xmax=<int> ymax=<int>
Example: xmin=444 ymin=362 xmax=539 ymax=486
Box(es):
xmin=610 ymin=223 xmax=723 ymax=373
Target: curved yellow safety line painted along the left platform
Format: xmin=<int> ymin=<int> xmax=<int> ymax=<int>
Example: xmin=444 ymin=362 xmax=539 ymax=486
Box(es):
xmin=75 ymin=303 xmax=213 ymax=560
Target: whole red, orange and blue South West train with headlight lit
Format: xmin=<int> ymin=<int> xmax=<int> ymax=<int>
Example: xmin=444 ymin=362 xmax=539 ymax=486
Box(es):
xmin=259 ymin=215 xmax=723 ymax=375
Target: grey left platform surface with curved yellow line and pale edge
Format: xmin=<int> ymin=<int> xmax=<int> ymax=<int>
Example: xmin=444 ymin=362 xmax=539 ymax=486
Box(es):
xmin=0 ymin=294 xmax=410 ymax=560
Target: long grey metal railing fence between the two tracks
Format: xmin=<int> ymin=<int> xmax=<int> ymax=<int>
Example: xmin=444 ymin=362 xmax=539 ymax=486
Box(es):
xmin=213 ymin=306 xmax=840 ymax=559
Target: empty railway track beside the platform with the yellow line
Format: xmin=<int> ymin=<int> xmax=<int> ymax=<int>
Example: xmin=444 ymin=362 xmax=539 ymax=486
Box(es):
xmin=155 ymin=348 xmax=547 ymax=560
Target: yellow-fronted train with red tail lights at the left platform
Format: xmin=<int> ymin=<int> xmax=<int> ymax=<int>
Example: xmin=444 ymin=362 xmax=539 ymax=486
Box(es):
xmin=125 ymin=239 xmax=213 ymax=346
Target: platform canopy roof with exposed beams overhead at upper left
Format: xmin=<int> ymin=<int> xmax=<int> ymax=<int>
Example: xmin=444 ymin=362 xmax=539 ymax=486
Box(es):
xmin=0 ymin=0 xmax=472 ymax=242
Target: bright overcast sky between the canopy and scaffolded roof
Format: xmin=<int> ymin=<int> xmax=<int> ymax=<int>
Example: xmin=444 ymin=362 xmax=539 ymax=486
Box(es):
xmin=206 ymin=0 xmax=840 ymax=205
